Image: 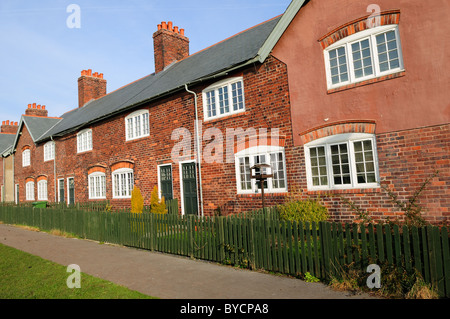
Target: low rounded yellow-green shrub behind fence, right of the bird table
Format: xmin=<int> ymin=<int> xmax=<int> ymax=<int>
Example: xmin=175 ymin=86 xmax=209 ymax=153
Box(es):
xmin=278 ymin=199 xmax=328 ymax=223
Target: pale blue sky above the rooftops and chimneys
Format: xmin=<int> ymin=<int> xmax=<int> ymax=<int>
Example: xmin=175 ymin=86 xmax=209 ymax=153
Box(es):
xmin=0 ymin=0 xmax=291 ymax=122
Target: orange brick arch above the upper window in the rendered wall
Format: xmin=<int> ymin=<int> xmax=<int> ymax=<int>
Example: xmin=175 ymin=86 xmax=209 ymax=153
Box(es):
xmin=318 ymin=10 xmax=400 ymax=49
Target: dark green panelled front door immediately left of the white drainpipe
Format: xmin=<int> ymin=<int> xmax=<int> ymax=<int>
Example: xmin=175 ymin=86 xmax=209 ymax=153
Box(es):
xmin=181 ymin=163 xmax=198 ymax=215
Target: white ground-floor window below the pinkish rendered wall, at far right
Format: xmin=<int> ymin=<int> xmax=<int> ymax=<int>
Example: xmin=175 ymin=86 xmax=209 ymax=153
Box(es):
xmin=304 ymin=133 xmax=379 ymax=190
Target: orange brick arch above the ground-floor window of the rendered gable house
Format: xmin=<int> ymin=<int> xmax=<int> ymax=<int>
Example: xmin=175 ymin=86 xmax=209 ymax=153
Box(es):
xmin=299 ymin=120 xmax=376 ymax=144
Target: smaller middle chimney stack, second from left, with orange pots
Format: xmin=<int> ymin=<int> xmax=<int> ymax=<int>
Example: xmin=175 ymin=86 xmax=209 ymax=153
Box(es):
xmin=78 ymin=69 xmax=106 ymax=107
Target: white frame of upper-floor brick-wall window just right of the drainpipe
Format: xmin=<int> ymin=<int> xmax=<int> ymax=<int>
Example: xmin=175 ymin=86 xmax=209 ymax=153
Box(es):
xmin=202 ymin=76 xmax=245 ymax=121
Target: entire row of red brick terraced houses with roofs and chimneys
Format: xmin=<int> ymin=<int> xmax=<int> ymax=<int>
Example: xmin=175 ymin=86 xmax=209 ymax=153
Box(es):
xmin=0 ymin=0 xmax=450 ymax=223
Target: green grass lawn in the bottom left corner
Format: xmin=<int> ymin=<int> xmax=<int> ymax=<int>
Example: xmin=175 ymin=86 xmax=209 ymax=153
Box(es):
xmin=0 ymin=244 xmax=154 ymax=299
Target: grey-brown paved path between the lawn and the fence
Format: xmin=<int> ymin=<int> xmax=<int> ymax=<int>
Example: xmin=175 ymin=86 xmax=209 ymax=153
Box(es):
xmin=0 ymin=224 xmax=371 ymax=299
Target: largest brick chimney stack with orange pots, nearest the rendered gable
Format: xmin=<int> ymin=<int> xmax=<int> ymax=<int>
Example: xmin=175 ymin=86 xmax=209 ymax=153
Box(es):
xmin=153 ymin=21 xmax=189 ymax=73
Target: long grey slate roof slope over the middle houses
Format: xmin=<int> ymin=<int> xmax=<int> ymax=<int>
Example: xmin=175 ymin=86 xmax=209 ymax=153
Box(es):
xmin=37 ymin=17 xmax=280 ymax=142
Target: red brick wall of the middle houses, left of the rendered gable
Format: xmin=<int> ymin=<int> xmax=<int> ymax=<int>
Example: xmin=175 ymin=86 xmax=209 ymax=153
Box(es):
xmin=33 ymin=58 xmax=295 ymax=214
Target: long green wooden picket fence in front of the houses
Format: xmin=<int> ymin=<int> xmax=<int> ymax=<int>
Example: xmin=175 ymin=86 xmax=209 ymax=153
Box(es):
xmin=0 ymin=206 xmax=450 ymax=297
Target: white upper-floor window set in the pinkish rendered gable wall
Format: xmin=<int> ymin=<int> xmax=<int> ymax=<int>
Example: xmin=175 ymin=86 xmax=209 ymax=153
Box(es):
xmin=324 ymin=25 xmax=404 ymax=89
